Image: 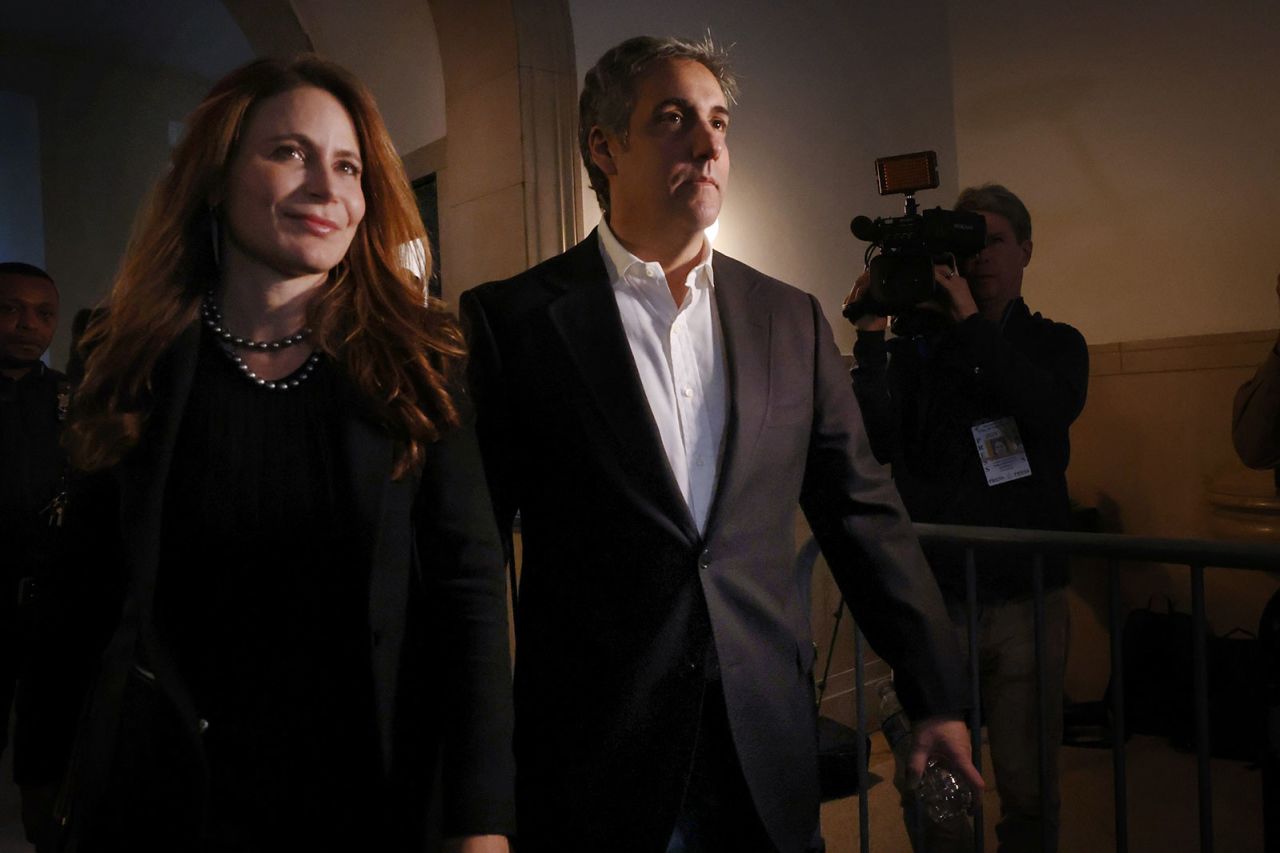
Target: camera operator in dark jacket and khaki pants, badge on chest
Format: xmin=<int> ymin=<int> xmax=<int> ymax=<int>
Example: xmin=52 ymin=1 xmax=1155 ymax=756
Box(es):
xmin=846 ymin=184 xmax=1089 ymax=853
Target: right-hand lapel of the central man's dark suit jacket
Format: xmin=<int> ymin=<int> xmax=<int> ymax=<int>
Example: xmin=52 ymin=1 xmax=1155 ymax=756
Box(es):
xmin=707 ymin=255 xmax=772 ymax=530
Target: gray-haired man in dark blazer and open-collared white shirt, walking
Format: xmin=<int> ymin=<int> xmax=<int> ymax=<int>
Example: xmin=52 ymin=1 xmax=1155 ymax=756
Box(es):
xmin=461 ymin=38 xmax=982 ymax=853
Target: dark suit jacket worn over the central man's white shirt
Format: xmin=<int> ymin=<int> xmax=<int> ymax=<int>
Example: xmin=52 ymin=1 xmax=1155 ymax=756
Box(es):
xmin=461 ymin=234 xmax=963 ymax=850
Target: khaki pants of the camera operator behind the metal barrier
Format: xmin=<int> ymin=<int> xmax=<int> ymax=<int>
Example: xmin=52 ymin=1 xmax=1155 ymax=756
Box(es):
xmin=895 ymin=589 xmax=1070 ymax=853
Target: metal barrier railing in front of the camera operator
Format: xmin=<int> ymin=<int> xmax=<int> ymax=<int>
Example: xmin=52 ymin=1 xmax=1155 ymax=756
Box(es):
xmin=814 ymin=524 xmax=1280 ymax=853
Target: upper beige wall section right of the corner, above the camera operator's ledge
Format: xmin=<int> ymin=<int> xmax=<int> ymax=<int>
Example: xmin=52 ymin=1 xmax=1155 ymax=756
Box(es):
xmin=948 ymin=0 xmax=1280 ymax=343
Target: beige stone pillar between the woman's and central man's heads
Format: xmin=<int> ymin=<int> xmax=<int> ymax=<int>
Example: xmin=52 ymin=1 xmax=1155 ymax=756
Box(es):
xmin=431 ymin=0 xmax=579 ymax=304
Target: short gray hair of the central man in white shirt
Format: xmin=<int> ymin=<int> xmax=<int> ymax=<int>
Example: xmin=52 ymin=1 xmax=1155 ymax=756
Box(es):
xmin=577 ymin=33 xmax=737 ymax=214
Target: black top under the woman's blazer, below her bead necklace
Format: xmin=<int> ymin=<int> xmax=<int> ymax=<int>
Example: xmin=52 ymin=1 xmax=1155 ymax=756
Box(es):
xmin=156 ymin=337 xmax=380 ymax=849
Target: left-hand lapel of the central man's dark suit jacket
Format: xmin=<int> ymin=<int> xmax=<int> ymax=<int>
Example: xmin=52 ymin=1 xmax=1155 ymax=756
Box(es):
xmin=549 ymin=232 xmax=699 ymax=540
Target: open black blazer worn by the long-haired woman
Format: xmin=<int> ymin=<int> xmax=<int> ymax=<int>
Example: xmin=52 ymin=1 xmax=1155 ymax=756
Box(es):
xmin=21 ymin=327 xmax=515 ymax=850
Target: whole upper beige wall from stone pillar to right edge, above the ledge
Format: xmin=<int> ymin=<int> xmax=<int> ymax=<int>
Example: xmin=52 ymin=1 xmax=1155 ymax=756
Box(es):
xmin=570 ymin=0 xmax=1280 ymax=351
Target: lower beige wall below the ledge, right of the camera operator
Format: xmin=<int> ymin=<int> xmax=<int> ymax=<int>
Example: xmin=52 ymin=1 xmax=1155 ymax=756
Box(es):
xmin=1068 ymin=330 xmax=1280 ymax=698
